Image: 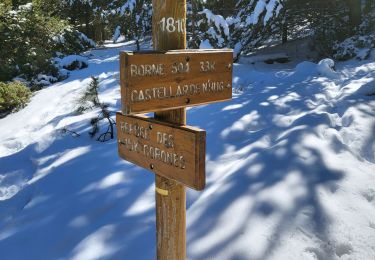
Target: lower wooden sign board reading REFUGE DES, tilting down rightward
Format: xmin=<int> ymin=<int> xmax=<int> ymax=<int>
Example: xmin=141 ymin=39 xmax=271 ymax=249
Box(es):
xmin=116 ymin=113 xmax=206 ymax=190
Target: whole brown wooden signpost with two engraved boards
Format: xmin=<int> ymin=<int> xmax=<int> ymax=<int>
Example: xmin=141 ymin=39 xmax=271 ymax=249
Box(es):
xmin=116 ymin=0 xmax=233 ymax=260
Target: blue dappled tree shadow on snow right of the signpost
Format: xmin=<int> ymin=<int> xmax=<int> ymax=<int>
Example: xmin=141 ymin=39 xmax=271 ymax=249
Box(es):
xmin=187 ymin=65 xmax=352 ymax=259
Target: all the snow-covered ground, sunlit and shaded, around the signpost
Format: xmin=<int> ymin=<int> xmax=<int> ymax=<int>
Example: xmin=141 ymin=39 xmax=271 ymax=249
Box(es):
xmin=0 ymin=41 xmax=375 ymax=260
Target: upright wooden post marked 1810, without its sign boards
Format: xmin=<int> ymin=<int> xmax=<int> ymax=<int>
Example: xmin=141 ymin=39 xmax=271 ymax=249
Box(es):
xmin=152 ymin=0 xmax=186 ymax=260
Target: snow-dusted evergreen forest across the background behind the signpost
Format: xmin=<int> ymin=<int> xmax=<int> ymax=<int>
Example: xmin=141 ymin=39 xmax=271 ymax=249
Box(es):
xmin=0 ymin=0 xmax=375 ymax=112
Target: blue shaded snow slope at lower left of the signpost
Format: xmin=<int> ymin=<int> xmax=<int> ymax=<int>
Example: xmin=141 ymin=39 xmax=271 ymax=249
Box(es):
xmin=0 ymin=133 xmax=155 ymax=259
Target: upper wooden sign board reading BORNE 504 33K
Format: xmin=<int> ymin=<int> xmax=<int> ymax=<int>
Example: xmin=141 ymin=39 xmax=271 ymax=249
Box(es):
xmin=120 ymin=50 xmax=233 ymax=114
